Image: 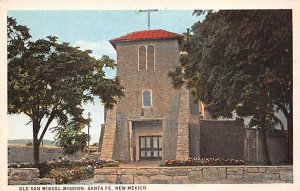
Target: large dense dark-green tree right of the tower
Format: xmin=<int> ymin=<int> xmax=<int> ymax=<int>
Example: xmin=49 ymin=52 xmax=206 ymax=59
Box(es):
xmin=169 ymin=10 xmax=293 ymax=164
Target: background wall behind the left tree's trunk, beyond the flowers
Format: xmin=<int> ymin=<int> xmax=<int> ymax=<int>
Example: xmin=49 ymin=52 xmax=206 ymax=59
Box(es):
xmin=8 ymin=145 xmax=86 ymax=163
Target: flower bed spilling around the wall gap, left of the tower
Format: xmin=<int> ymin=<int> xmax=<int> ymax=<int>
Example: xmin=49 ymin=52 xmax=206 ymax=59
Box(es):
xmin=9 ymin=156 xmax=119 ymax=184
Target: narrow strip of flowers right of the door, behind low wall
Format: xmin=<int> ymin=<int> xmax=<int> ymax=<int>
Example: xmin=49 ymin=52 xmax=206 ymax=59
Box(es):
xmin=160 ymin=157 xmax=245 ymax=166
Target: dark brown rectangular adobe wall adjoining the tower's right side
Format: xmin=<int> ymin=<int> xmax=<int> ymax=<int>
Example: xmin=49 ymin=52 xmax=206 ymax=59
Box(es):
xmin=199 ymin=120 xmax=244 ymax=159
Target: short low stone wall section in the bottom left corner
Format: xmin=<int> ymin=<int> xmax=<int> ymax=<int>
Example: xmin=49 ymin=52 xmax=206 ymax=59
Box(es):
xmin=8 ymin=168 xmax=55 ymax=185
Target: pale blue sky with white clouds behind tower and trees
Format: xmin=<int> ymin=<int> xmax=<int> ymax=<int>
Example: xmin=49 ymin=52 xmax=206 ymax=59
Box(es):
xmin=7 ymin=10 xmax=203 ymax=144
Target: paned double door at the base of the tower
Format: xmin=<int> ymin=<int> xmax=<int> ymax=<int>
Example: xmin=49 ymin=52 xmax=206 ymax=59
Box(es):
xmin=139 ymin=136 xmax=163 ymax=160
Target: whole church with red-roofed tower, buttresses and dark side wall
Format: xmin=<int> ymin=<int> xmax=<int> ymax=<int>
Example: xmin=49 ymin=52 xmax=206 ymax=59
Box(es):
xmin=99 ymin=30 xmax=288 ymax=161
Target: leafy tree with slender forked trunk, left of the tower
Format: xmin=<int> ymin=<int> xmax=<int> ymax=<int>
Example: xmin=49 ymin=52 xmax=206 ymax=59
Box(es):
xmin=7 ymin=17 xmax=123 ymax=163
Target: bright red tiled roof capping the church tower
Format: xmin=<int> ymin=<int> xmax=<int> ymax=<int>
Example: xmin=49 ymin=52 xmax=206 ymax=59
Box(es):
xmin=110 ymin=29 xmax=182 ymax=47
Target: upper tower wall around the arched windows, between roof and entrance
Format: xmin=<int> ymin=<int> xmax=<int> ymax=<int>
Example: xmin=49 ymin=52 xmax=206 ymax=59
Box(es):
xmin=116 ymin=39 xmax=180 ymax=121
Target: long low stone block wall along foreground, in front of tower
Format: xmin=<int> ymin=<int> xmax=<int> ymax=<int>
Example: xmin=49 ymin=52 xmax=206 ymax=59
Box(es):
xmin=94 ymin=166 xmax=293 ymax=184
